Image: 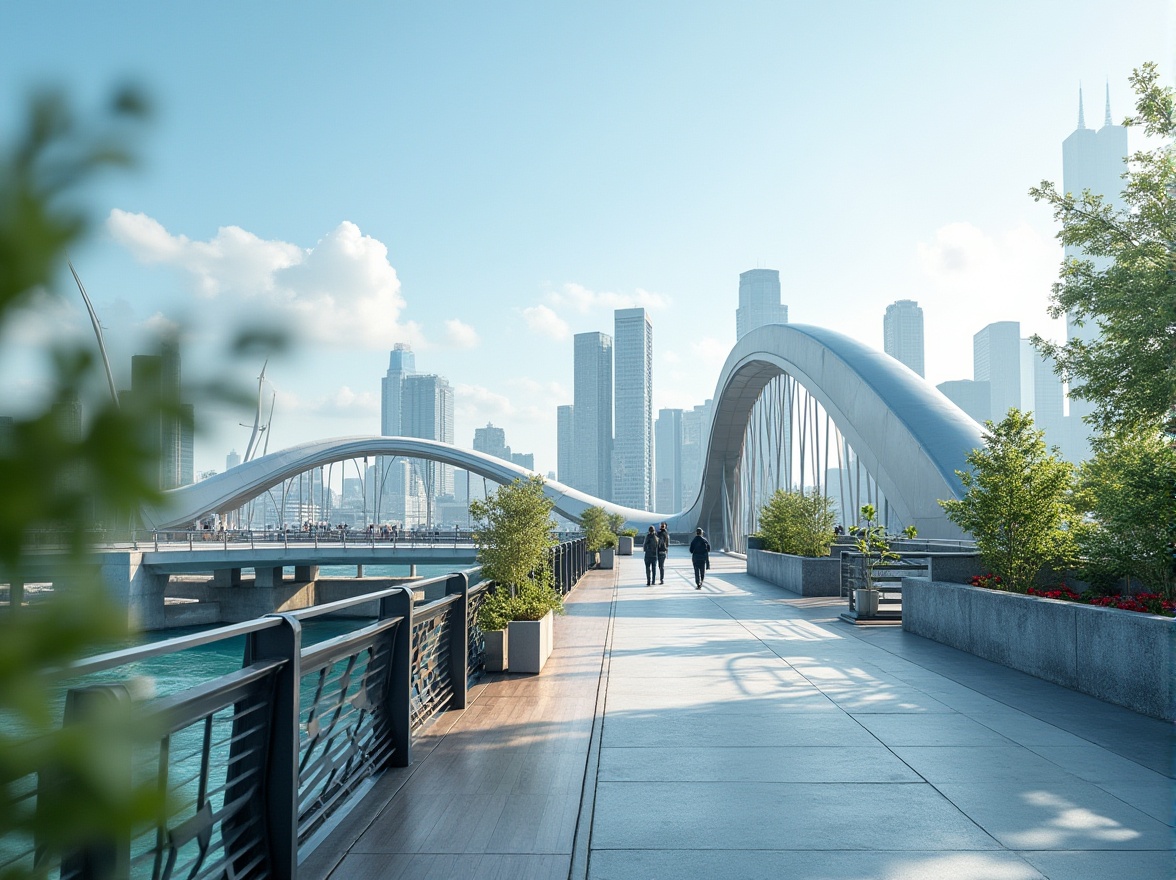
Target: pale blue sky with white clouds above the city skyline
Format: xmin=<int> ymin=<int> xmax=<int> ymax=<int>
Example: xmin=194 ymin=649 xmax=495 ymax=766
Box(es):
xmin=0 ymin=0 xmax=1176 ymax=482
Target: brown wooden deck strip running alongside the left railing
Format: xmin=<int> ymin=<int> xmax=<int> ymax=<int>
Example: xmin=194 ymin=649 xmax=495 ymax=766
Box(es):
xmin=300 ymin=571 xmax=616 ymax=880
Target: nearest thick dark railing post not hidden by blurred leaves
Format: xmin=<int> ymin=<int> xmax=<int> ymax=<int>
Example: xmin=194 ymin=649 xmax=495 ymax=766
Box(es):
xmin=238 ymin=614 xmax=302 ymax=880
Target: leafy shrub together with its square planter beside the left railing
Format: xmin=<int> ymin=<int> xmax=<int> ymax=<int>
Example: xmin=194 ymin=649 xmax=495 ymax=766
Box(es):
xmin=469 ymin=475 xmax=563 ymax=673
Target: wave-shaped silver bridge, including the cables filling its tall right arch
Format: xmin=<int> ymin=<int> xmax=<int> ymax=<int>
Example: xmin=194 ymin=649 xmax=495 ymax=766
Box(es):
xmin=143 ymin=325 xmax=983 ymax=546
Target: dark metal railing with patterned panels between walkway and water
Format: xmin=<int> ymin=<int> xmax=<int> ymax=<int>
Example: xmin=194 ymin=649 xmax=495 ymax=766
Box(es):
xmin=11 ymin=539 xmax=587 ymax=880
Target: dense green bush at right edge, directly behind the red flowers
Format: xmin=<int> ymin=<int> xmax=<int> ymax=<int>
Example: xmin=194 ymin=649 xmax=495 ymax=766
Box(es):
xmin=1078 ymin=431 xmax=1176 ymax=598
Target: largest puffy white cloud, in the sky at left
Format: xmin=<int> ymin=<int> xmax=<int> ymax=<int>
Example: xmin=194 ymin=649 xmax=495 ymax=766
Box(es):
xmin=106 ymin=209 xmax=421 ymax=348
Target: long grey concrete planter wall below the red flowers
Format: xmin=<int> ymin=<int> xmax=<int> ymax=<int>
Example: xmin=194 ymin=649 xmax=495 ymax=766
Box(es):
xmin=902 ymin=578 xmax=1176 ymax=721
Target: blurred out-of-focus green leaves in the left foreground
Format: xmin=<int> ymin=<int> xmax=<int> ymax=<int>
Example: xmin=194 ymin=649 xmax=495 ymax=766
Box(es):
xmin=0 ymin=85 xmax=165 ymax=880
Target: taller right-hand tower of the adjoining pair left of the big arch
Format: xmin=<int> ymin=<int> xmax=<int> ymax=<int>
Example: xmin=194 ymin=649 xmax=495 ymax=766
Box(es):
xmin=613 ymin=308 xmax=654 ymax=511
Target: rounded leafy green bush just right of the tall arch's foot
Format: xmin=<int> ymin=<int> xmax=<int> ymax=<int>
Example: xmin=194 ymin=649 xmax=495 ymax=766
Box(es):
xmin=940 ymin=409 xmax=1081 ymax=593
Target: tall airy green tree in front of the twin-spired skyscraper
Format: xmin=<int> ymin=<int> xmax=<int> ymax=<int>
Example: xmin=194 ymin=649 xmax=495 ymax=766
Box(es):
xmin=1029 ymin=64 xmax=1176 ymax=434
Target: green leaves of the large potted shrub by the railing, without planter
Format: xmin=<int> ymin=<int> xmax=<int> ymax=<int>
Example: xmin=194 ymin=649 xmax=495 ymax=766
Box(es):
xmin=469 ymin=475 xmax=563 ymax=629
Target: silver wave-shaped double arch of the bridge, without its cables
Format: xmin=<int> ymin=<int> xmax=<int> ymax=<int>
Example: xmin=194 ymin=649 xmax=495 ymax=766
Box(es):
xmin=151 ymin=324 xmax=983 ymax=538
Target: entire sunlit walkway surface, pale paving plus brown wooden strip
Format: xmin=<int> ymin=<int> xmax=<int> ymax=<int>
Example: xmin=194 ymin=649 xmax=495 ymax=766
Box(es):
xmin=301 ymin=557 xmax=1174 ymax=880
